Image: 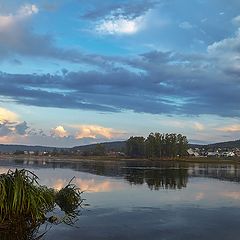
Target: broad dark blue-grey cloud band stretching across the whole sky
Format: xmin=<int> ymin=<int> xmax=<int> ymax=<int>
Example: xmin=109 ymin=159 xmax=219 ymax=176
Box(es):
xmin=0 ymin=45 xmax=240 ymax=117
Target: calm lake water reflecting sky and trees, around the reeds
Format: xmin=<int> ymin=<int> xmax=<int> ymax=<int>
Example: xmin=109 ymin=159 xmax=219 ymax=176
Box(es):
xmin=0 ymin=160 xmax=240 ymax=240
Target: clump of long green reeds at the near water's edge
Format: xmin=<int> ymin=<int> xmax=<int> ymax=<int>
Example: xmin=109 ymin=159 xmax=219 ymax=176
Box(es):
xmin=0 ymin=169 xmax=82 ymax=240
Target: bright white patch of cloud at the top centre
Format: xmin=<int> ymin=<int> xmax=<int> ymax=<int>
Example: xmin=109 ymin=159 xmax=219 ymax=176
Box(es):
xmin=96 ymin=15 xmax=143 ymax=35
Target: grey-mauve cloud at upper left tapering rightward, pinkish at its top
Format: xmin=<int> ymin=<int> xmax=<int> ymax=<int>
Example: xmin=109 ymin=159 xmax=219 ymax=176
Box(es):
xmin=0 ymin=5 xmax=117 ymax=66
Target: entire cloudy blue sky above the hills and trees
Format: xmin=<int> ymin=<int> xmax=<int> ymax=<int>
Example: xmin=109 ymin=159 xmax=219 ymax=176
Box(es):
xmin=0 ymin=0 xmax=240 ymax=147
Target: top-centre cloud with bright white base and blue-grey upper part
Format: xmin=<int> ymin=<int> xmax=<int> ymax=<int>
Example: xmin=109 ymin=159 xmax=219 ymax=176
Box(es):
xmin=87 ymin=0 xmax=160 ymax=35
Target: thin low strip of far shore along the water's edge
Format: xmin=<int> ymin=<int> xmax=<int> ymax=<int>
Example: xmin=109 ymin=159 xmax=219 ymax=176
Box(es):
xmin=0 ymin=154 xmax=240 ymax=164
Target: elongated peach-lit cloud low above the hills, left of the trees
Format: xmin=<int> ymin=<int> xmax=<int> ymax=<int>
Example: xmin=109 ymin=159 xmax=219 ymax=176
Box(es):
xmin=72 ymin=125 xmax=123 ymax=139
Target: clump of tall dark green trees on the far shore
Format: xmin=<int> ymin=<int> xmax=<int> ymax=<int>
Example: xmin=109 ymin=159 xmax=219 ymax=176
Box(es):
xmin=126 ymin=132 xmax=188 ymax=158
